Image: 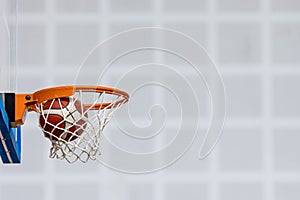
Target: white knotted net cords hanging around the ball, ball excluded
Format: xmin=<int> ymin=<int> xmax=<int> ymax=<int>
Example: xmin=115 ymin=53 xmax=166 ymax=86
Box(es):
xmin=36 ymin=91 xmax=122 ymax=163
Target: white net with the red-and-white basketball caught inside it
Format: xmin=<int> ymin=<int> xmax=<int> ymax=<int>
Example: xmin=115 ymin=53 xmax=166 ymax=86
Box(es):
xmin=36 ymin=91 xmax=122 ymax=163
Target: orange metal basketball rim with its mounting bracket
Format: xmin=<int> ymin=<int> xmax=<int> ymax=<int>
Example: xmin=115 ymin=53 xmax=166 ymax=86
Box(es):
xmin=13 ymin=85 xmax=129 ymax=126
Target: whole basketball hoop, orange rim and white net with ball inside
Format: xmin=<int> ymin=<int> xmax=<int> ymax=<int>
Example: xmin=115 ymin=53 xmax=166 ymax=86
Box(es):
xmin=12 ymin=86 xmax=129 ymax=163
